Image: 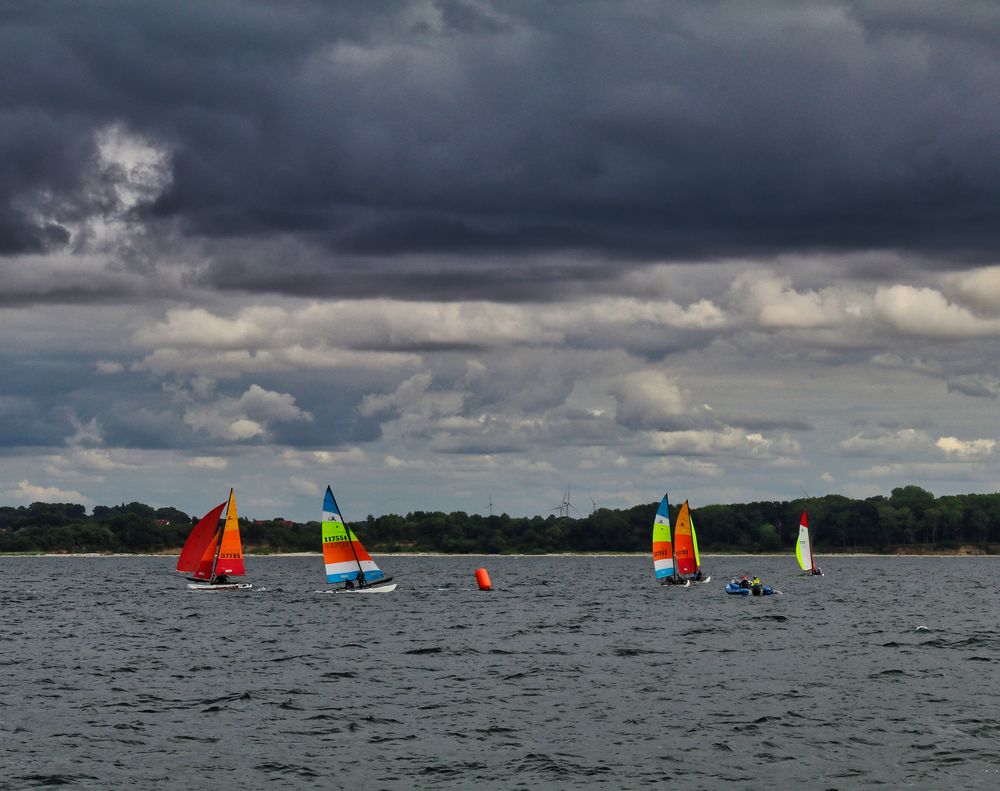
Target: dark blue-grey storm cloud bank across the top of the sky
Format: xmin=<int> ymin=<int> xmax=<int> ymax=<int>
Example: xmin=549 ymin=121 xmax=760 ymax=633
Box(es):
xmin=0 ymin=0 xmax=1000 ymax=296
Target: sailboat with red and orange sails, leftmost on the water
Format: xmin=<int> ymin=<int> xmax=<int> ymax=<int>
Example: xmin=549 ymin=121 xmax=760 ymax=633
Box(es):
xmin=177 ymin=489 xmax=253 ymax=590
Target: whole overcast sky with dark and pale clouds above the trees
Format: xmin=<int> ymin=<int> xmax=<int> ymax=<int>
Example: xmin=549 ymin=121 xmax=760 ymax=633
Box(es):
xmin=0 ymin=0 xmax=1000 ymax=520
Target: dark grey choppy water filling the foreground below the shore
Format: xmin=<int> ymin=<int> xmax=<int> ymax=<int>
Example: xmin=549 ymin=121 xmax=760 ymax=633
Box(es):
xmin=0 ymin=557 xmax=1000 ymax=791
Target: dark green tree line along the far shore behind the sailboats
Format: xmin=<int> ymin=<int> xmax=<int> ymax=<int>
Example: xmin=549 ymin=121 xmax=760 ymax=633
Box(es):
xmin=0 ymin=486 xmax=1000 ymax=554
